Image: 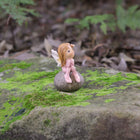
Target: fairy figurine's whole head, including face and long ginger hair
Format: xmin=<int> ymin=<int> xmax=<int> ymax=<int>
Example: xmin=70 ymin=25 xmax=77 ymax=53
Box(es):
xmin=58 ymin=43 xmax=74 ymax=67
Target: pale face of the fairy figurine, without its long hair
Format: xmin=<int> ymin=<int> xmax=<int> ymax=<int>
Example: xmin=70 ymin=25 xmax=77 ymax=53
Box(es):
xmin=65 ymin=43 xmax=74 ymax=59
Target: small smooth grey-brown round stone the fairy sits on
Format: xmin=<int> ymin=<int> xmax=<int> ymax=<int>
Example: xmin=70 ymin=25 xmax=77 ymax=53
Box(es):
xmin=54 ymin=71 xmax=84 ymax=92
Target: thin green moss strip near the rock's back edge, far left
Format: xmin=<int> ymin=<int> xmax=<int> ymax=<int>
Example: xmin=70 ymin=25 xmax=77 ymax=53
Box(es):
xmin=0 ymin=61 xmax=32 ymax=72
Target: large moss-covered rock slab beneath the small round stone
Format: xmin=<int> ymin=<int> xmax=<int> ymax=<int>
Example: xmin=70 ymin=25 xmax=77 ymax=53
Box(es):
xmin=0 ymin=58 xmax=140 ymax=140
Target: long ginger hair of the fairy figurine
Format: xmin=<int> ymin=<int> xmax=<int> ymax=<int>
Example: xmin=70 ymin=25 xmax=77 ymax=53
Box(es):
xmin=58 ymin=43 xmax=74 ymax=67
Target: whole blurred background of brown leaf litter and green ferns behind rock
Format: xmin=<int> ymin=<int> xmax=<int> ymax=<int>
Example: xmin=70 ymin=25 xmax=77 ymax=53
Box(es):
xmin=0 ymin=0 xmax=140 ymax=73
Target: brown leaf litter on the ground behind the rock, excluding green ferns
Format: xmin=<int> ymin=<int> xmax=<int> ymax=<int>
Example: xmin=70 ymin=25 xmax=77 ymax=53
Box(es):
xmin=0 ymin=0 xmax=140 ymax=73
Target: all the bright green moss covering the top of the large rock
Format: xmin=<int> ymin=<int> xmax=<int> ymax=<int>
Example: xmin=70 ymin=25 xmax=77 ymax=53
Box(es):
xmin=0 ymin=58 xmax=140 ymax=132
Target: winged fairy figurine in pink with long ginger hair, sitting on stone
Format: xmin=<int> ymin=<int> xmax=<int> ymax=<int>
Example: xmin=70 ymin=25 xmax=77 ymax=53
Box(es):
xmin=51 ymin=43 xmax=80 ymax=83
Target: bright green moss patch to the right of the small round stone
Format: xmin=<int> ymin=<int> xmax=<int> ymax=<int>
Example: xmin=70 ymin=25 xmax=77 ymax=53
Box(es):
xmin=84 ymin=70 xmax=140 ymax=96
